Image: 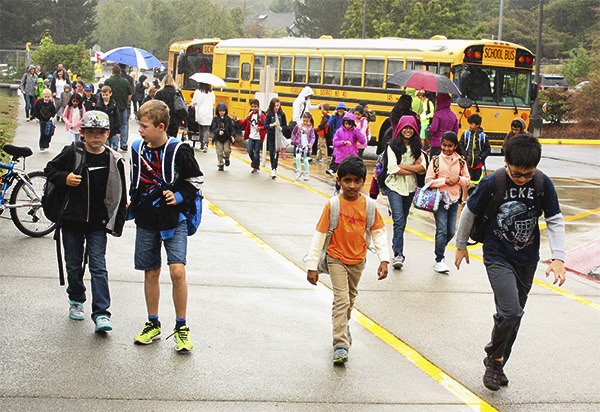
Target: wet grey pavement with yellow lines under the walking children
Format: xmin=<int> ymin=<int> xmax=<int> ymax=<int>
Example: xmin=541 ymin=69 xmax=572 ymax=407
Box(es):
xmin=0 ymin=101 xmax=600 ymax=411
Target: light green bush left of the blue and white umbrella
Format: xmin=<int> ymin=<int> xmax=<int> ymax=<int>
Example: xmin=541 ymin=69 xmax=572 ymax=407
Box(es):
xmin=31 ymin=36 xmax=94 ymax=81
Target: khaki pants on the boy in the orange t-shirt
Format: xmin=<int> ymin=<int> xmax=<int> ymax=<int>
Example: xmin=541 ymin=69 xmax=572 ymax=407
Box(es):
xmin=327 ymin=256 xmax=366 ymax=348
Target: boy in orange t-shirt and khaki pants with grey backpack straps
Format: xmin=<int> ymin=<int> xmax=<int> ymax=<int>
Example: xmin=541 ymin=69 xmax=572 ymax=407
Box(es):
xmin=306 ymin=156 xmax=389 ymax=364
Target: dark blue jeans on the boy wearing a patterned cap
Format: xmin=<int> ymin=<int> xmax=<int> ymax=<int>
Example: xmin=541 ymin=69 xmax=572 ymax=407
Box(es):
xmin=62 ymin=228 xmax=110 ymax=321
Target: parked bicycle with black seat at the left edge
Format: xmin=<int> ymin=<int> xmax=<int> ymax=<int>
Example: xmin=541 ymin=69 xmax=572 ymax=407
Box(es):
xmin=0 ymin=144 xmax=56 ymax=237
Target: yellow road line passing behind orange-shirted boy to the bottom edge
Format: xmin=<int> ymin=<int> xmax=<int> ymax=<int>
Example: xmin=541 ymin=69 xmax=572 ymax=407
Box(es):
xmin=204 ymin=197 xmax=496 ymax=412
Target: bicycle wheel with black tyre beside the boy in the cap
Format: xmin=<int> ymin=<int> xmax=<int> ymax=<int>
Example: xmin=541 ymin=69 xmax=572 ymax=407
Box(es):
xmin=10 ymin=171 xmax=56 ymax=237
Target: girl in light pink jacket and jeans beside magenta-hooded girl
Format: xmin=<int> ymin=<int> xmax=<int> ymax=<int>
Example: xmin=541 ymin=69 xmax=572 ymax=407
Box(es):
xmin=425 ymin=132 xmax=471 ymax=273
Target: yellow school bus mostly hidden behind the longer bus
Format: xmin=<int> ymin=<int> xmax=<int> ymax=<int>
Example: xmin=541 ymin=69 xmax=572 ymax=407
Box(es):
xmin=168 ymin=38 xmax=219 ymax=103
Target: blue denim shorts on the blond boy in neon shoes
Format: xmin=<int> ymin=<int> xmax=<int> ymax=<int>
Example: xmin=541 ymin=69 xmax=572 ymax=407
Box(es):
xmin=134 ymin=220 xmax=187 ymax=271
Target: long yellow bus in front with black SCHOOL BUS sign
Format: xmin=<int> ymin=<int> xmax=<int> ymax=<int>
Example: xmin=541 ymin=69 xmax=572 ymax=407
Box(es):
xmin=212 ymin=36 xmax=534 ymax=152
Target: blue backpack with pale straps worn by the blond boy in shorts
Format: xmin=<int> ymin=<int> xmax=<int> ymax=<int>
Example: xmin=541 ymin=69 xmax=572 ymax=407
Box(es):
xmin=131 ymin=137 xmax=203 ymax=236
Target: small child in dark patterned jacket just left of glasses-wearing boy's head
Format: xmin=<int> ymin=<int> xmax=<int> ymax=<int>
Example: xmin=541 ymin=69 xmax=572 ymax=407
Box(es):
xmin=460 ymin=113 xmax=492 ymax=187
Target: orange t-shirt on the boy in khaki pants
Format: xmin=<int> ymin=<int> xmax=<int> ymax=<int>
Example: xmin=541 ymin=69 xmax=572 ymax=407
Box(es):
xmin=317 ymin=195 xmax=385 ymax=265
